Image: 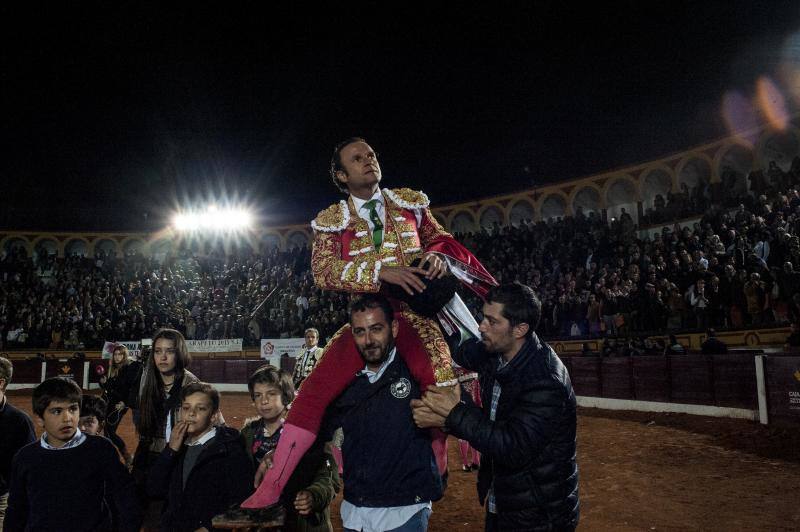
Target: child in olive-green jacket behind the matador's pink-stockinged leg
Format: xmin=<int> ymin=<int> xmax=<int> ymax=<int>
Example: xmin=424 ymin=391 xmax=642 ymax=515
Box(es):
xmin=242 ymin=365 xmax=340 ymax=532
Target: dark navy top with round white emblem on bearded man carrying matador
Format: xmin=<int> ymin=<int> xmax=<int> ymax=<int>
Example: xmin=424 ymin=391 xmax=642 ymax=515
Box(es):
xmin=326 ymin=353 xmax=443 ymax=508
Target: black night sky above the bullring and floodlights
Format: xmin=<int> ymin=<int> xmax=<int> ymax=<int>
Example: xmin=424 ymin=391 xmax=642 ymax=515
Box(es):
xmin=0 ymin=1 xmax=800 ymax=231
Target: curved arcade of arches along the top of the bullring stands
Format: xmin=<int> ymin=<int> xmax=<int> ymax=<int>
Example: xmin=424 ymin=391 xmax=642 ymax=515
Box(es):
xmin=0 ymin=119 xmax=800 ymax=258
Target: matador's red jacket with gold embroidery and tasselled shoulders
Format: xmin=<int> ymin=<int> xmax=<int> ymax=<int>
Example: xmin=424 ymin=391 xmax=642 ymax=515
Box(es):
xmin=311 ymin=188 xmax=497 ymax=296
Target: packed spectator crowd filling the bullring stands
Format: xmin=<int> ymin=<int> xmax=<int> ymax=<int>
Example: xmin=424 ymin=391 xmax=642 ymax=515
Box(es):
xmin=0 ymin=158 xmax=800 ymax=350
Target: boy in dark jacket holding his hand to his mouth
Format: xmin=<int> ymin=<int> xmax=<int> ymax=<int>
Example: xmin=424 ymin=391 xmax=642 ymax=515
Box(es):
xmin=147 ymin=382 xmax=254 ymax=532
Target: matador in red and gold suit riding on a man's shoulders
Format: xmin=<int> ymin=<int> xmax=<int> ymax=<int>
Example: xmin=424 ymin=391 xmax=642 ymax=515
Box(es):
xmin=242 ymin=138 xmax=497 ymax=508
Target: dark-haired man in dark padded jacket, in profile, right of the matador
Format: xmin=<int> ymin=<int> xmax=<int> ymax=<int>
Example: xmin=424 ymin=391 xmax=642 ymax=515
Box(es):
xmin=412 ymin=283 xmax=579 ymax=531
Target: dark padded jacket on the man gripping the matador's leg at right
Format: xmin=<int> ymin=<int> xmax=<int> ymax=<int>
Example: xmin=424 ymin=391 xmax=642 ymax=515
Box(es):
xmin=446 ymin=334 xmax=579 ymax=530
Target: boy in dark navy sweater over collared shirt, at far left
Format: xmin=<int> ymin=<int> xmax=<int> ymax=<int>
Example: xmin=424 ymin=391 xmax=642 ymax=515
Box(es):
xmin=4 ymin=377 xmax=141 ymax=532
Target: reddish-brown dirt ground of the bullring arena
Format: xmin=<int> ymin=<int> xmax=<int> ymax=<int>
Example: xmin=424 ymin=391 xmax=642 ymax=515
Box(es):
xmin=9 ymin=392 xmax=800 ymax=532
